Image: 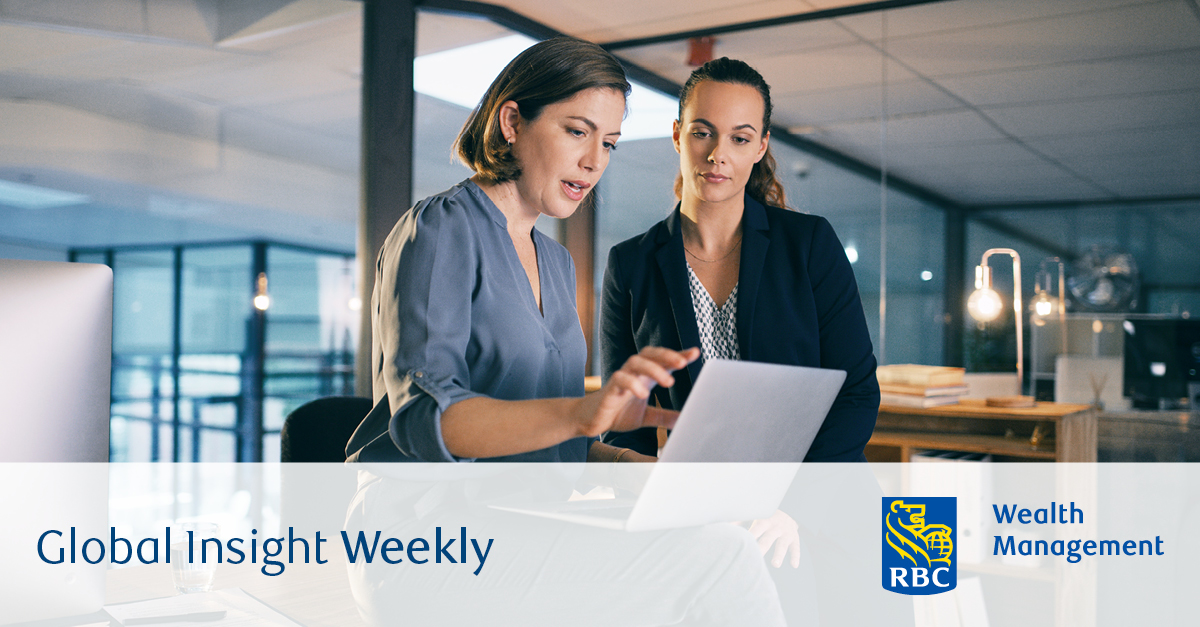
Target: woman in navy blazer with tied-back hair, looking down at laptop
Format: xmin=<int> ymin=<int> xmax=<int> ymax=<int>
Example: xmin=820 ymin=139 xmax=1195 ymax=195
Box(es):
xmin=600 ymin=59 xmax=880 ymax=461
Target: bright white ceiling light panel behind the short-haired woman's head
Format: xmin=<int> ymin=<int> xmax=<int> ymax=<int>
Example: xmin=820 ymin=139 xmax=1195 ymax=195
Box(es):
xmin=413 ymin=35 xmax=679 ymax=142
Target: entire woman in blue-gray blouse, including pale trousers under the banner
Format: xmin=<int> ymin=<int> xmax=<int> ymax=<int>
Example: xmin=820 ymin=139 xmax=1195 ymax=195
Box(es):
xmin=346 ymin=38 xmax=782 ymax=626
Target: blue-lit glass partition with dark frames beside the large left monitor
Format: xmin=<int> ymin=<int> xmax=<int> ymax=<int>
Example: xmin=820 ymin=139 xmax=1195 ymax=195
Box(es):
xmin=71 ymin=241 xmax=352 ymax=461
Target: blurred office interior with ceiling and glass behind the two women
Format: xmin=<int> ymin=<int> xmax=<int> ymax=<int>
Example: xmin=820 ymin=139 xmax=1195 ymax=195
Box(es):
xmin=0 ymin=0 xmax=1200 ymax=461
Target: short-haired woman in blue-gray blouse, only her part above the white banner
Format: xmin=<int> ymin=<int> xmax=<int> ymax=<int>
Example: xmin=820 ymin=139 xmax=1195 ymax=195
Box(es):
xmin=347 ymin=37 xmax=698 ymax=461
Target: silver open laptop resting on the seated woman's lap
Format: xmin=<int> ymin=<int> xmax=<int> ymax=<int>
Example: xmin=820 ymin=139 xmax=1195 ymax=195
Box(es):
xmin=492 ymin=359 xmax=846 ymax=531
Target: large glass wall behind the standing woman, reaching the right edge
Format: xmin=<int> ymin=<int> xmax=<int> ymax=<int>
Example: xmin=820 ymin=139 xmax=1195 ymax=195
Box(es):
xmin=596 ymin=0 xmax=1200 ymax=389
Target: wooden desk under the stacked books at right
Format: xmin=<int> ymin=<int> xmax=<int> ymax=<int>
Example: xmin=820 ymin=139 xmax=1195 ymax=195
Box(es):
xmin=866 ymin=402 xmax=1097 ymax=462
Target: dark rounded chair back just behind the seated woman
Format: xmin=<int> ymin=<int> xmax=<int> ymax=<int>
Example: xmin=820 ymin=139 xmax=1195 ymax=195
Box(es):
xmin=280 ymin=396 xmax=373 ymax=464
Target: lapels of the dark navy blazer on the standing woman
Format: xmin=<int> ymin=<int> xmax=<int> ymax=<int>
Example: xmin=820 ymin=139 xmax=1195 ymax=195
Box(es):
xmin=654 ymin=195 xmax=770 ymax=381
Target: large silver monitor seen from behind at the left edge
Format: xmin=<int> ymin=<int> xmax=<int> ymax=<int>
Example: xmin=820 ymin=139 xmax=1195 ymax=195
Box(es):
xmin=0 ymin=259 xmax=113 ymax=625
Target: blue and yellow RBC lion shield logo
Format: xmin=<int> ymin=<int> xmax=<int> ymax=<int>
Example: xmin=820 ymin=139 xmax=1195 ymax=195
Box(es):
xmin=883 ymin=496 xmax=959 ymax=595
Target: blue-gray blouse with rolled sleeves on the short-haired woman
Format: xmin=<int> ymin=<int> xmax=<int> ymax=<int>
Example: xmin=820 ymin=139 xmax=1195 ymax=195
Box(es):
xmin=355 ymin=180 xmax=590 ymax=461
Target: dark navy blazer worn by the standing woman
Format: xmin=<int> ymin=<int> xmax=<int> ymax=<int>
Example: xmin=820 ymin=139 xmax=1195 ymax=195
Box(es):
xmin=600 ymin=196 xmax=880 ymax=461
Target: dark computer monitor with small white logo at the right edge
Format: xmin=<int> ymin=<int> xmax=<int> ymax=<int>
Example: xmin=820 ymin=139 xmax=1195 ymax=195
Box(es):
xmin=1123 ymin=320 xmax=1200 ymax=410
